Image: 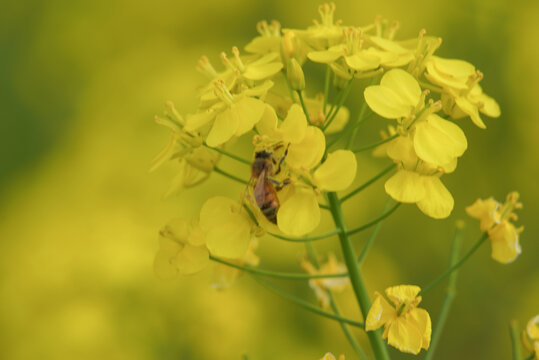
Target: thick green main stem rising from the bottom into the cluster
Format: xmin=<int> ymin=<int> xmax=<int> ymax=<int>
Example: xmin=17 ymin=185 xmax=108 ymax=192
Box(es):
xmin=327 ymin=192 xmax=389 ymax=360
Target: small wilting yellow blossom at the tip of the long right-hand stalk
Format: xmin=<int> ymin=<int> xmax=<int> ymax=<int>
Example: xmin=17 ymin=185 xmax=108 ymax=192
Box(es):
xmin=466 ymin=192 xmax=523 ymax=264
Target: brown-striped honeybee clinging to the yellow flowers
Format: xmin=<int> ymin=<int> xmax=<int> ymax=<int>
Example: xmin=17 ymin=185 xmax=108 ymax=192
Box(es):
xmin=251 ymin=145 xmax=289 ymax=224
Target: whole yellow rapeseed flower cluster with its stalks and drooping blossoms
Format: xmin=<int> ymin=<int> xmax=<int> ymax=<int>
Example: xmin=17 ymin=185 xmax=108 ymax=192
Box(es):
xmin=152 ymin=4 xmax=524 ymax=359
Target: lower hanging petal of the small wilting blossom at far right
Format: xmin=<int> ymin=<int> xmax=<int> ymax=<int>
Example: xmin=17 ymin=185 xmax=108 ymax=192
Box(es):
xmin=488 ymin=221 xmax=522 ymax=264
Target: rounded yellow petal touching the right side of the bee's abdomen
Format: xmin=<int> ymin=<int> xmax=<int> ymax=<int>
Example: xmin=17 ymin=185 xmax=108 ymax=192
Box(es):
xmin=277 ymin=187 xmax=320 ymax=236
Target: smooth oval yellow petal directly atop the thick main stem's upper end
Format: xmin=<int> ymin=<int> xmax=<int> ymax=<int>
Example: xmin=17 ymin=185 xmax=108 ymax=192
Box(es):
xmin=314 ymin=150 xmax=357 ymax=191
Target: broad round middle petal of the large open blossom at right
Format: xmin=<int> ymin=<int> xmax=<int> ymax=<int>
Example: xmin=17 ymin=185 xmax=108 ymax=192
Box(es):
xmin=414 ymin=114 xmax=468 ymax=166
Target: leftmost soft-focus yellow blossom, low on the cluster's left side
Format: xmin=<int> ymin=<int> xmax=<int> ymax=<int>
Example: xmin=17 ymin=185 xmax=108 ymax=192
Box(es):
xmin=154 ymin=218 xmax=210 ymax=279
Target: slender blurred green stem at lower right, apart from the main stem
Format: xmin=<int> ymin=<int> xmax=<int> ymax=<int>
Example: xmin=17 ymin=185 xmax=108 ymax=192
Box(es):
xmin=425 ymin=225 xmax=462 ymax=360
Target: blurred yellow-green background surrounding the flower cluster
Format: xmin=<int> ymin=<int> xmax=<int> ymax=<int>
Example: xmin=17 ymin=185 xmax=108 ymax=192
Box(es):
xmin=0 ymin=0 xmax=539 ymax=360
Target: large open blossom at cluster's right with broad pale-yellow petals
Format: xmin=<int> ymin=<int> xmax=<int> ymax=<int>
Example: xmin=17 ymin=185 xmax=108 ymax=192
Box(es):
xmin=365 ymin=69 xmax=468 ymax=219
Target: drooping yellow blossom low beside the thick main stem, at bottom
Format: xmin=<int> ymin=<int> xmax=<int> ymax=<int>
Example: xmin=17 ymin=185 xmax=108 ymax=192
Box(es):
xmin=365 ymin=285 xmax=432 ymax=354
